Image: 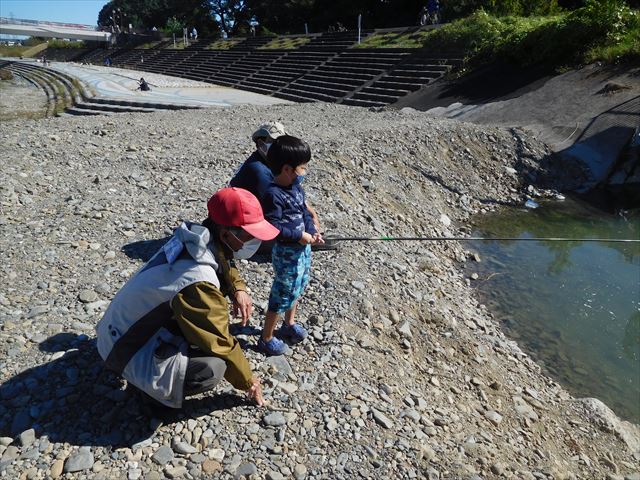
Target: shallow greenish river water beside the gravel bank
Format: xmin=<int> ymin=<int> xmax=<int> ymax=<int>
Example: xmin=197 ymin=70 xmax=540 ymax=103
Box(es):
xmin=467 ymin=200 xmax=640 ymax=423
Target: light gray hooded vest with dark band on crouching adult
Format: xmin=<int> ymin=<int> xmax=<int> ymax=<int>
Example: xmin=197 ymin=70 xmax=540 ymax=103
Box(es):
xmin=96 ymin=223 xmax=220 ymax=408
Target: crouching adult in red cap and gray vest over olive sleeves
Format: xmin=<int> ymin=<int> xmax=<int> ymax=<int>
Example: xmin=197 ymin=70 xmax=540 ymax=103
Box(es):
xmin=96 ymin=188 xmax=279 ymax=408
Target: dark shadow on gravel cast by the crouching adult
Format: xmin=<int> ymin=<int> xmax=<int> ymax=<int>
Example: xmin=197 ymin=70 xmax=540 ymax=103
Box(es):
xmin=0 ymin=333 xmax=250 ymax=449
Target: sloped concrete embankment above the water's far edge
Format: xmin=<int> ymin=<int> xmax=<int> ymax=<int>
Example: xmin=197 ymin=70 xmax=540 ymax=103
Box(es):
xmin=398 ymin=65 xmax=640 ymax=207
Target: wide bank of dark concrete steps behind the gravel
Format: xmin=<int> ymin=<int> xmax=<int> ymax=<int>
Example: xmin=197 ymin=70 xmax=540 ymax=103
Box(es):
xmin=46 ymin=28 xmax=462 ymax=107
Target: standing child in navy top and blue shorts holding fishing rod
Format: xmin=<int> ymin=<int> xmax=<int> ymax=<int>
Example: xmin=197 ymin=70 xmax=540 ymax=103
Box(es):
xmin=258 ymin=135 xmax=324 ymax=355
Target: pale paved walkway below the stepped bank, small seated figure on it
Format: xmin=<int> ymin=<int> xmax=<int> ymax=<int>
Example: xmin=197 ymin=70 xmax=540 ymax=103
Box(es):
xmin=49 ymin=62 xmax=292 ymax=107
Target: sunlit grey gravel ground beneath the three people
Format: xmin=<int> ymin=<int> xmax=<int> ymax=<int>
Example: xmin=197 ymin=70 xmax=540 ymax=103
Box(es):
xmin=0 ymin=104 xmax=640 ymax=480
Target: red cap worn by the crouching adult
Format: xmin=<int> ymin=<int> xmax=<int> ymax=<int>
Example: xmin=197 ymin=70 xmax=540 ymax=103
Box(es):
xmin=207 ymin=187 xmax=280 ymax=240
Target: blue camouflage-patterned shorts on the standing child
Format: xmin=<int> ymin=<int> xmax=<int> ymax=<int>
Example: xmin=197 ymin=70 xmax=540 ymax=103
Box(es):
xmin=269 ymin=242 xmax=311 ymax=313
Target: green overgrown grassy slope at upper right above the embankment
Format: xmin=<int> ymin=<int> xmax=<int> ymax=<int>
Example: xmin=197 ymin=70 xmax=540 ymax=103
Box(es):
xmin=360 ymin=0 xmax=640 ymax=68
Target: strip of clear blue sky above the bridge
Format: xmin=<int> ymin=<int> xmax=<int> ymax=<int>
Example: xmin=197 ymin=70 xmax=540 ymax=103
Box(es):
xmin=0 ymin=0 xmax=108 ymax=26
